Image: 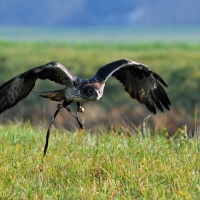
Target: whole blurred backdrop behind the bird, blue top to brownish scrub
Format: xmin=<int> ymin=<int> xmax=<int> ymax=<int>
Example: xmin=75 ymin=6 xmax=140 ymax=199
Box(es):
xmin=0 ymin=0 xmax=200 ymax=132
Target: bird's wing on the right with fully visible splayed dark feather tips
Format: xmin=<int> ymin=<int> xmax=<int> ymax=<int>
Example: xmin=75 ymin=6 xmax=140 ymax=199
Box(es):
xmin=94 ymin=59 xmax=170 ymax=114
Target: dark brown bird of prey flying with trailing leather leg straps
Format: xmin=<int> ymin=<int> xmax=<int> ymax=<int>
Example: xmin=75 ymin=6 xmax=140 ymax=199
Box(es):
xmin=0 ymin=59 xmax=170 ymax=155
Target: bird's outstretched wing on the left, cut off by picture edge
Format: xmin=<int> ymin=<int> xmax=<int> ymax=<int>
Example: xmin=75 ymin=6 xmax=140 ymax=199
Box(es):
xmin=0 ymin=62 xmax=76 ymax=113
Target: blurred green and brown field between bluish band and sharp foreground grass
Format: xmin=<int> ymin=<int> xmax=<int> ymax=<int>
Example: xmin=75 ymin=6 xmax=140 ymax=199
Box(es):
xmin=0 ymin=41 xmax=200 ymax=132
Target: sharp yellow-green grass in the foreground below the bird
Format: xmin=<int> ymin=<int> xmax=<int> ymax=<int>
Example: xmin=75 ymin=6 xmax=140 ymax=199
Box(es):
xmin=0 ymin=122 xmax=200 ymax=199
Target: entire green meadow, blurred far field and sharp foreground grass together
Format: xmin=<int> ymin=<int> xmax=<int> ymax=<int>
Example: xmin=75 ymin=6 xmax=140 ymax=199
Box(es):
xmin=0 ymin=41 xmax=200 ymax=199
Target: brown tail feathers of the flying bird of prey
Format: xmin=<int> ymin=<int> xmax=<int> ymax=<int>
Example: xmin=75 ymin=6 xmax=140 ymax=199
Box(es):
xmin=39 ymin=89 xmax=65 ymax=101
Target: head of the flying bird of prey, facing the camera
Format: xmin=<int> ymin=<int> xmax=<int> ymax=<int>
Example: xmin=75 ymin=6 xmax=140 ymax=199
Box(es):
xmin=80 ymin=86 xmax=101 ymax=101
